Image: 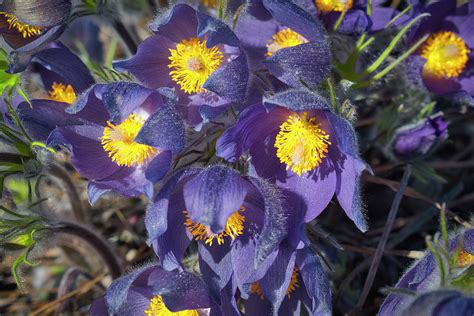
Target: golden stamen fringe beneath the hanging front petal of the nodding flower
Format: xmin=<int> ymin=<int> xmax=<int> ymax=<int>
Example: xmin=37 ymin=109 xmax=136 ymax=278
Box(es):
xmin=183 ymin=207 xmax=245 ymax=246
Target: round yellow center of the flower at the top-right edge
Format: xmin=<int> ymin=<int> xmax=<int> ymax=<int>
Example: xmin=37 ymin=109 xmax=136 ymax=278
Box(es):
xmin=421 ymin=32 xmax=470 ymax=78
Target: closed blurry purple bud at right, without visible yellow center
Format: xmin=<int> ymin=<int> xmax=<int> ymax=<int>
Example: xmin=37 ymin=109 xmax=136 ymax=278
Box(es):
xmin=391 ymin=113 xmax=448 ymax=159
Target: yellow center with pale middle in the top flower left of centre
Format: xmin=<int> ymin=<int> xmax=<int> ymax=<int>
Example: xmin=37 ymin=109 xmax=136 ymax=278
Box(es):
xmin=168 ymin=38 xmax=223 ymax=94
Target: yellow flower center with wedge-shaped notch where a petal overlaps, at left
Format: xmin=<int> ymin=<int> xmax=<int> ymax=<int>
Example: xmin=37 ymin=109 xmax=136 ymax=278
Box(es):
xmin=101 ymin=114 xmax=158 ymax=167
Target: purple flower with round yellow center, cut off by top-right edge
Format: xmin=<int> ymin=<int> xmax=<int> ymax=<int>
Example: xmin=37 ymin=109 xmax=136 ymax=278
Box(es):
xmin=407 ymin=0 xmax=474 ymax=103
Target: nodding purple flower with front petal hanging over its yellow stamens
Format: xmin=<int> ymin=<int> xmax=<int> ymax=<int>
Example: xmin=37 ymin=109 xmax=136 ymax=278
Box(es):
xmin=145 ymin=165 xmax=288 ymax=300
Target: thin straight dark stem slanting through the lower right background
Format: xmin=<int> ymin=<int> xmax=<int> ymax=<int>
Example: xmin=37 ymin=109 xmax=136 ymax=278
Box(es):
xmin=352 ymin=165 xmax=411 ymax=312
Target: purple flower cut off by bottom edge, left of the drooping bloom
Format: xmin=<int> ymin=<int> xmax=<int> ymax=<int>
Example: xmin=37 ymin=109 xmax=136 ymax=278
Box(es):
xmin=89 ymin=265 xmax=211 ymax=316
